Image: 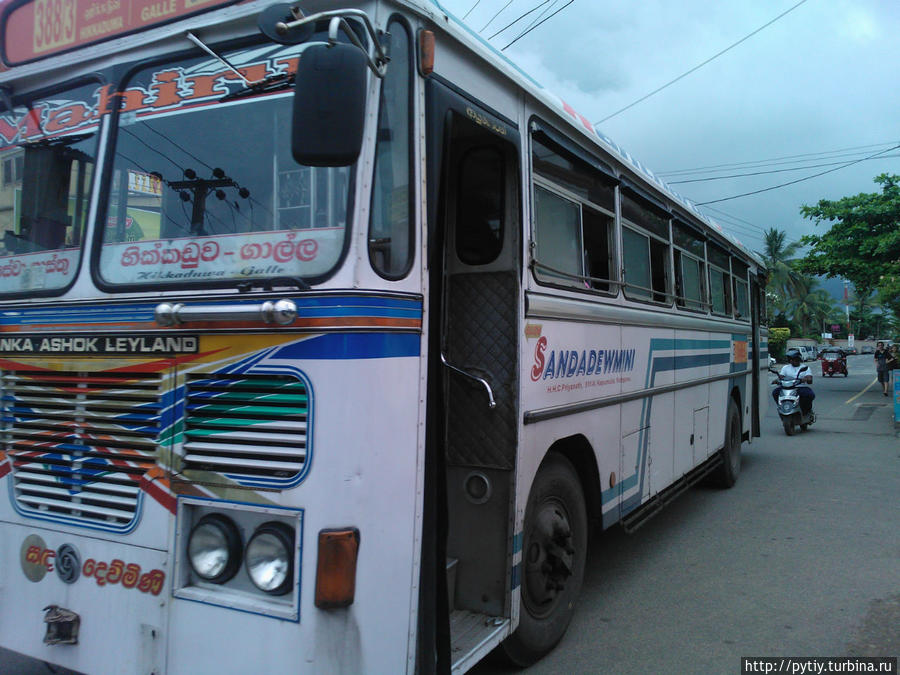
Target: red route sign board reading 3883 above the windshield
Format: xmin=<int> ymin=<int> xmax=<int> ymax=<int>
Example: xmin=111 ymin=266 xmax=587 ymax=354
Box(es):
xmin=2 ymin=0 xmax=235 ymax=65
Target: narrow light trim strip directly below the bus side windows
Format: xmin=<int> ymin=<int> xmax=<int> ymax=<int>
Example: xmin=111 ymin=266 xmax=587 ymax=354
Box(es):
xmin=525 ymin=291 xmax=751 ymax=333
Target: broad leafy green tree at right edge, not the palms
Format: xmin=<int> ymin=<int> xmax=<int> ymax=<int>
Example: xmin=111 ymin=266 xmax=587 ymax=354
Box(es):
xmin=800 ymin=174 xmax=900 ymax=304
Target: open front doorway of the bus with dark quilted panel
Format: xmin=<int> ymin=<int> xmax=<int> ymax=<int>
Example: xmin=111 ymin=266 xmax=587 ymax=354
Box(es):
xmin=427 ymin=78 xmax=521 ymax=644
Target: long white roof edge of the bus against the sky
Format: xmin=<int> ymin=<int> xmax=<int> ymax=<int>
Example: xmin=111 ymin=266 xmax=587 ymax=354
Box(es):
xmin=408 ymin=0 xmax=765 ymax=267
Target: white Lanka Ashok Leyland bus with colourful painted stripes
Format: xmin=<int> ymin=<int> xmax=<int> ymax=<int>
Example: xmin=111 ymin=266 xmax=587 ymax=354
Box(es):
xmin=0 ymin=0 xmax=768 ymax=674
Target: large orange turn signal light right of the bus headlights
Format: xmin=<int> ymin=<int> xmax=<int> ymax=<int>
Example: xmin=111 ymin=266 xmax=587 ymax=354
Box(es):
xmin=316 ymin=527 xmax=359 ymax=609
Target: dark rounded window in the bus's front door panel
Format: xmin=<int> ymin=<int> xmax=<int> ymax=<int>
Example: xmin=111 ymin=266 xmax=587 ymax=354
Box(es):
xmin=456 ymin=147 xmax=506 ymax=265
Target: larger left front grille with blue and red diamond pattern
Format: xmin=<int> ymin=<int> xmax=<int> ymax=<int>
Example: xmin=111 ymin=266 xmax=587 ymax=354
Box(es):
xmin=0 ymin=370 xmax=163 ymax=532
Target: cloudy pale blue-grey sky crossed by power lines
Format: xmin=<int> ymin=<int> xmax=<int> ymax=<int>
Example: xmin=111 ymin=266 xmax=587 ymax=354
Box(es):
xmin=432 ymin=0 xmax=900 ymax=250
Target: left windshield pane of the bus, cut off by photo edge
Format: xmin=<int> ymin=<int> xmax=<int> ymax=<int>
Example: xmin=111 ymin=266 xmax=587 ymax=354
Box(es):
xmin=0 ymin=84 xmax=99 ymax=294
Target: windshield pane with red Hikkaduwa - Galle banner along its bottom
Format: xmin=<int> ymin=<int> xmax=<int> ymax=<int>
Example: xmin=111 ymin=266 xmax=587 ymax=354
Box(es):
xmin=100 ymin=45 xmax=352 ymax=287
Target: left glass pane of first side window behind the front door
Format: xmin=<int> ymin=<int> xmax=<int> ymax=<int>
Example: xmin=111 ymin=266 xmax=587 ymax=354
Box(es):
xmin=534 ymin=185 xmax=585 ymax=287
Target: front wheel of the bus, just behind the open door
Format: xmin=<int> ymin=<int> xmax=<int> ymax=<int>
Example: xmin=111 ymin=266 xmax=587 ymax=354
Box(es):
xmin=503 ymin=454 xmax=588 ymax=666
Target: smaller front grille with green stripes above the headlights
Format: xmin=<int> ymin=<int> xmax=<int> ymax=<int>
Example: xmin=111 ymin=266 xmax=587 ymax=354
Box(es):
xmin=183 ymin=374 xmax=310 ymax=488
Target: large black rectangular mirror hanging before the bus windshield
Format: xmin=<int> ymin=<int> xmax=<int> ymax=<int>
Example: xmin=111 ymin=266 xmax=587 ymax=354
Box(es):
xmin=291 ymin=43 xmax=367 ymax=166
